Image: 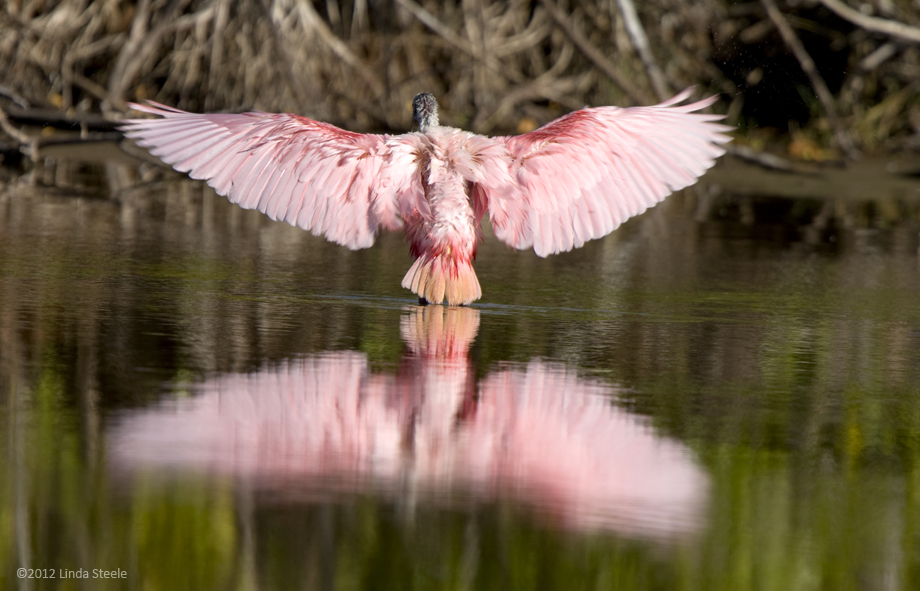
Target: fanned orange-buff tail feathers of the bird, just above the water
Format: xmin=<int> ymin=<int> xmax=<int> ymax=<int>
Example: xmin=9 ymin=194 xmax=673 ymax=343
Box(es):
xmin=402 ymin=255 xmax=482 ymax=306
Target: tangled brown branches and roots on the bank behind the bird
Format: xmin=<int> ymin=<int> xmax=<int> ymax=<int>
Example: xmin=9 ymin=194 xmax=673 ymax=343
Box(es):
xmin=0 ymin=0 xmax=920 ymax=152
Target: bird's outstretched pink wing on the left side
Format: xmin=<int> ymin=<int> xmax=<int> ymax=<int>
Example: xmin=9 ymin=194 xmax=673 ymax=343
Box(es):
xmin=121 ymin=103 xmax=423 ymax=249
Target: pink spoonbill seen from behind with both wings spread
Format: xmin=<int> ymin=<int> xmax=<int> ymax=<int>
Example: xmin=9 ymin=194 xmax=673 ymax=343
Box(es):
xmin=122 ymin=89 xmax=731 ymax=305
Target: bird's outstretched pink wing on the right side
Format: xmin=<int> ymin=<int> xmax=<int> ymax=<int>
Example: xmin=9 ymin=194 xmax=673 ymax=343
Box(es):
xmin=478 ymin=89 xmax=731 ymax=256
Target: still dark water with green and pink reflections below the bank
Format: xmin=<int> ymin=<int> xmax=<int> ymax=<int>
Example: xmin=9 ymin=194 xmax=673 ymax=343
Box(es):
xmin=0 ymin=155 xmax=920 ymax=590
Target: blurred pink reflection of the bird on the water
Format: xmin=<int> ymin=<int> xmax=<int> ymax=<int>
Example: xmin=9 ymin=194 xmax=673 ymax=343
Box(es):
xmin=109 ymin=306 xmax=707 ymax=538
